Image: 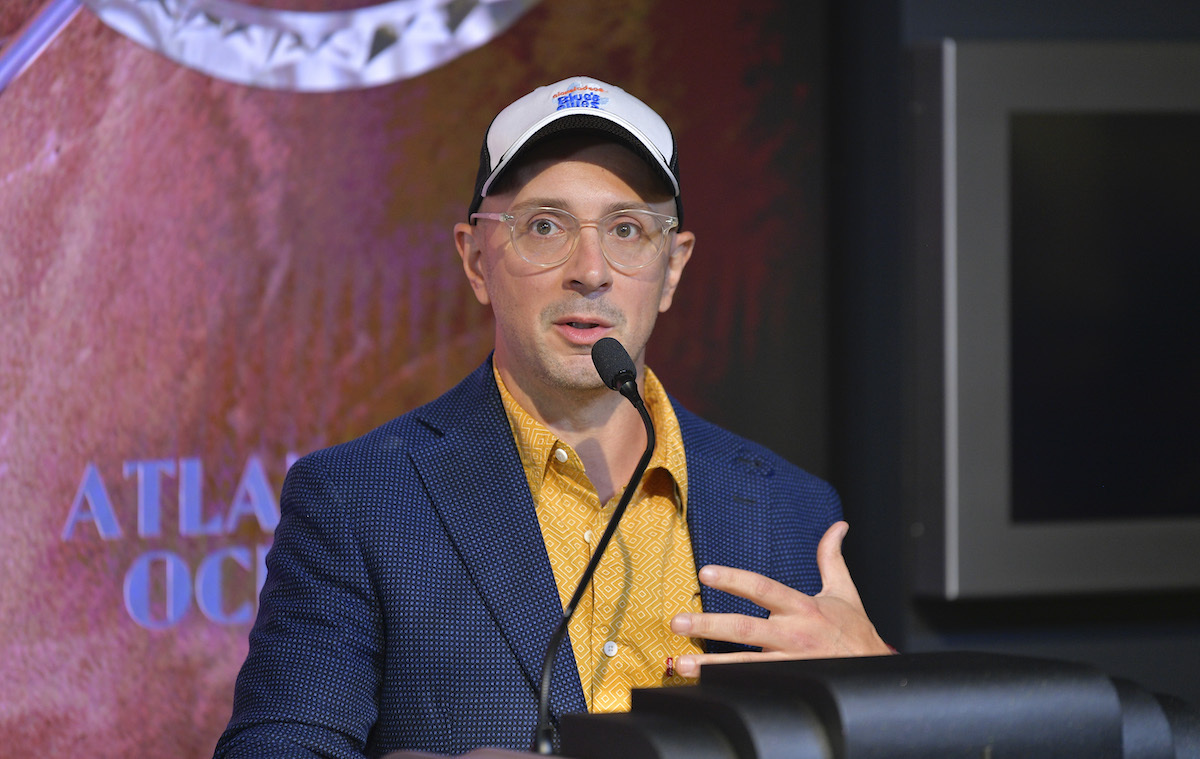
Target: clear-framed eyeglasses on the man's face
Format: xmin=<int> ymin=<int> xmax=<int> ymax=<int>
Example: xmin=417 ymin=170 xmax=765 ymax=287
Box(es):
xmin=470 ymin=207 xmax=679 ymax=269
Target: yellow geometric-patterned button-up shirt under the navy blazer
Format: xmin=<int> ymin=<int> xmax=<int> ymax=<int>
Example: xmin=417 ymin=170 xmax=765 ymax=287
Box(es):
xmin=493 ymin=369 xmax=703 ymax=712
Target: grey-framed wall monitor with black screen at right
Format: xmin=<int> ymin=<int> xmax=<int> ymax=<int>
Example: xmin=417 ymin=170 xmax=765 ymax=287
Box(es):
xmin=908 ymin=41 xmax=1200 ymax=599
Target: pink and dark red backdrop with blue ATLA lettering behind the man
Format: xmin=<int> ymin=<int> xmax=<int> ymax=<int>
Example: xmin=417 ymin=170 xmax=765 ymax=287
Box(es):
xmin=0 ymin=0 xmax=826 ymax=757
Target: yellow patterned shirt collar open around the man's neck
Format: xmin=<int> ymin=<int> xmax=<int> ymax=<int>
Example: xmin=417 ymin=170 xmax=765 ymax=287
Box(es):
xmin=492 ymin=363 xmax=688 ymax=514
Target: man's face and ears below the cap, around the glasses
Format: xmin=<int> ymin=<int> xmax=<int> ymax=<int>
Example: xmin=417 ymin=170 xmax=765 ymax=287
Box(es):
xmin=455 ymin=138 xmax=695 ymax=395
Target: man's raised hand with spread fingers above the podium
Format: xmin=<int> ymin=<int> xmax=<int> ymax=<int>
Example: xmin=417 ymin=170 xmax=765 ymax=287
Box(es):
xmin=671 ymin=521 xmax=893 ymax=677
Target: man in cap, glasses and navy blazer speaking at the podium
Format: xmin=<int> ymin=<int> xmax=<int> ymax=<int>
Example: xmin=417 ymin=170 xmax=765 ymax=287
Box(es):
xmin=216 ymin=78 xmax=888 ymax=757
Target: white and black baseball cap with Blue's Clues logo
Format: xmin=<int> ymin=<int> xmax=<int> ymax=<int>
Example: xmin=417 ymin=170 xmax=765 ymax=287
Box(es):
xmin=467 ymin=77 xmax=683 ymax=219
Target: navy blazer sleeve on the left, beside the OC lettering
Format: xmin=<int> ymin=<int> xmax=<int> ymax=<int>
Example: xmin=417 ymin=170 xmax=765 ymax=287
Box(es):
xmin=214 ymin=456 xmax=384 ymax=759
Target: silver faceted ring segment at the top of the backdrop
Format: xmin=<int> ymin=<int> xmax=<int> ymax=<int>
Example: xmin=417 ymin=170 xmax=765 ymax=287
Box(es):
xmin=83 ymin=0 xmax=538 ymax=92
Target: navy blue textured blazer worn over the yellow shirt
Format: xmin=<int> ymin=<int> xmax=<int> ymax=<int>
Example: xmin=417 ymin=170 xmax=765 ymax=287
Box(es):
xmin=215 ymin=360 xmax=841 ymax=758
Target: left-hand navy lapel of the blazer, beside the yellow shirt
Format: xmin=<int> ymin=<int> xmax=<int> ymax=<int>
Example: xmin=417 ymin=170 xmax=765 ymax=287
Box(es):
xmin=413 ymin=361 xmax=587 ymax=717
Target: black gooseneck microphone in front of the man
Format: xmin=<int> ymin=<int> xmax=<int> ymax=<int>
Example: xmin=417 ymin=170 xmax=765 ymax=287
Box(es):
xmin=534 ymin=337 xmax=654 ymax=755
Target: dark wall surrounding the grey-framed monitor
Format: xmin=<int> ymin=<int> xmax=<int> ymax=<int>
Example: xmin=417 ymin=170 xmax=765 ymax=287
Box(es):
xmin=828 ymin=0 xmax=1200 ymax=704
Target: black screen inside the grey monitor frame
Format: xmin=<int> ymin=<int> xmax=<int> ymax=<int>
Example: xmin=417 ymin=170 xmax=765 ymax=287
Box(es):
xmin=1010 ymin=113 xmax=1200 ymax=522
